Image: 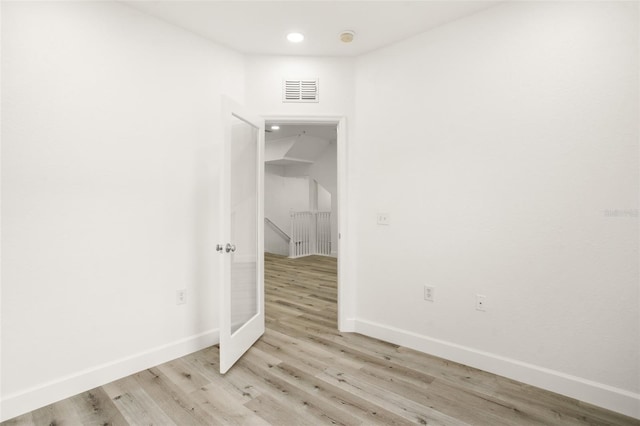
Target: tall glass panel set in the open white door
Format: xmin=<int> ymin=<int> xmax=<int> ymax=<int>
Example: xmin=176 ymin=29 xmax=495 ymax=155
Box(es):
xmin=230 ymin=116 xmax=259 ymax=334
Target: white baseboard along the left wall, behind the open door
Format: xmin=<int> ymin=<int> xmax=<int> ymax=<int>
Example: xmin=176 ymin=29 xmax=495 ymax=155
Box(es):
xmin=0 ymin=329 xmax=220 ymax=422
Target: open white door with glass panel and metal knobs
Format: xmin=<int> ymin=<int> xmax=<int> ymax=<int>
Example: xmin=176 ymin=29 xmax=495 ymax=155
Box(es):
xmin=217 ymin=99 xmax=264 ymax=373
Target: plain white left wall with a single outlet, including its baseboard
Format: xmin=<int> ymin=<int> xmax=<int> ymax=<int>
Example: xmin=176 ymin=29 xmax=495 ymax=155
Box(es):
xmin=1 ymin=2 xmax=244 ymax=419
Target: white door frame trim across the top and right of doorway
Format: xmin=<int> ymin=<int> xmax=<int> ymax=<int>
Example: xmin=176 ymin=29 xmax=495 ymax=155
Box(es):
xmin=262 ymin=114 xmax=355 ymax=332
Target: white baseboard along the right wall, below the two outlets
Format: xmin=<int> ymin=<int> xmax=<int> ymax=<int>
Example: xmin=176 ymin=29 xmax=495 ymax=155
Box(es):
xmin=354 ymin=319 xmax=640 ymax=419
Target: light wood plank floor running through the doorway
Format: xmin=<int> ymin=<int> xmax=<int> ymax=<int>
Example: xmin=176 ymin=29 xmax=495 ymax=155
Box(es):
xmin=2 ymin=255 xmax=640 ymax=426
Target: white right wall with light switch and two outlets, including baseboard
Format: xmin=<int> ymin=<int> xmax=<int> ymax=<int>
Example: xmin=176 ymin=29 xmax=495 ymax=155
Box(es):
xmin=350 ymin=2 xmax=640 ymax=417
